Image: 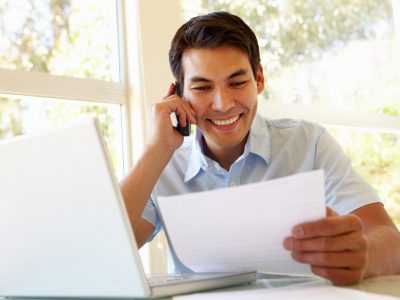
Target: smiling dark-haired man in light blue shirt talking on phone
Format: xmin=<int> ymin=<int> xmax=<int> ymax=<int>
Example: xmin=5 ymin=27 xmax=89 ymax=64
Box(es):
xmin=121 ymin=12 xmax=400 ymax=285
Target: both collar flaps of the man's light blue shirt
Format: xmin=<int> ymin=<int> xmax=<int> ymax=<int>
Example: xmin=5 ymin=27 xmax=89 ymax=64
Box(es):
xmin=185 ymin=113 xmax=271 ymax=182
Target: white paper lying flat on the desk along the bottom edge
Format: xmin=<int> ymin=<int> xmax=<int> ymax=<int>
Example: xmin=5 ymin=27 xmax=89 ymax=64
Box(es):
xmin=173 ymin=285 xmax=398 ymax=300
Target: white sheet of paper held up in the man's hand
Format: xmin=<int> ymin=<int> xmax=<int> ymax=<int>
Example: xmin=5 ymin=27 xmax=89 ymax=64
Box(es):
xmin=157 ymin=170 xmax=325 ymax=275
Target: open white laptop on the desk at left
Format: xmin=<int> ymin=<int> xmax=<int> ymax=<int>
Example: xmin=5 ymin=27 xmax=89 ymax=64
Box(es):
xmin=0 ymin=118 xmax=256 ymax=298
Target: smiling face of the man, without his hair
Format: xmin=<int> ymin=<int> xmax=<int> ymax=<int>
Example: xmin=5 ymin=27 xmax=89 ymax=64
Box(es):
xmin=182 ymin=46 xmax=264 ymax=153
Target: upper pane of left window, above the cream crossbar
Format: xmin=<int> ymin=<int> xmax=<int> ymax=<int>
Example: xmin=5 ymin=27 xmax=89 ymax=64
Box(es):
xmin=0 ymin=0 xmax=120 ymax=81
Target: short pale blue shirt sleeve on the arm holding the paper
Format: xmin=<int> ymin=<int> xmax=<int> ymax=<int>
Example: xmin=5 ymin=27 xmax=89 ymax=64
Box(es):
xmin=315 ymin=130 xmax=380 ymax=215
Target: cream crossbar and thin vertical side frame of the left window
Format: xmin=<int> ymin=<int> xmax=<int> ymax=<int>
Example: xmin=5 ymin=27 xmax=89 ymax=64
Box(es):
xmin=0 ymin=0 xmax=132 ymax=172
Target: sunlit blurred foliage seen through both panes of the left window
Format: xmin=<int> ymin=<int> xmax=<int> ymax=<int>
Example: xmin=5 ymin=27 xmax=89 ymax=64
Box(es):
xmin=0 ymin=0 xmax=121 ymax=176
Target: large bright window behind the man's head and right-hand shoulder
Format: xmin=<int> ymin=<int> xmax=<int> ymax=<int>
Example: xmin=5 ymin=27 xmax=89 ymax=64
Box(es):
xmin=182 ymin=0 xmax=400 ymax=227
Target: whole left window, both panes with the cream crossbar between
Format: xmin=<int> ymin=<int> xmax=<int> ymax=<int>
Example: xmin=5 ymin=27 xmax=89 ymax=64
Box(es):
xmin=0 ymin=0 xmax=128 ymax=178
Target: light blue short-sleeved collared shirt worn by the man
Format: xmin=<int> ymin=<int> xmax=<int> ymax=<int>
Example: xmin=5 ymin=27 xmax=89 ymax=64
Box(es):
xmin=142 ymin=114 xmax=380 ymax=272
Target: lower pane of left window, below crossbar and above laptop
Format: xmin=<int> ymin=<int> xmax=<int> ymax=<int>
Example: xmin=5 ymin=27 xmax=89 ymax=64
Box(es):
xmin=0 ymin=95 xmax=124 ymax=178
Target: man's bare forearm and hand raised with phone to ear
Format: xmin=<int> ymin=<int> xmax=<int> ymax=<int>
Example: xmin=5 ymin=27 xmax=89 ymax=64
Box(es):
xmin=121 ymin=84 xmax=196 ymax=246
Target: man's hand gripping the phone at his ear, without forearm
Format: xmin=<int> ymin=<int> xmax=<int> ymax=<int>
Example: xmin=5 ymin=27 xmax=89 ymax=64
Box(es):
xmin=149 ymin=83 xmax=196 ymax=155
